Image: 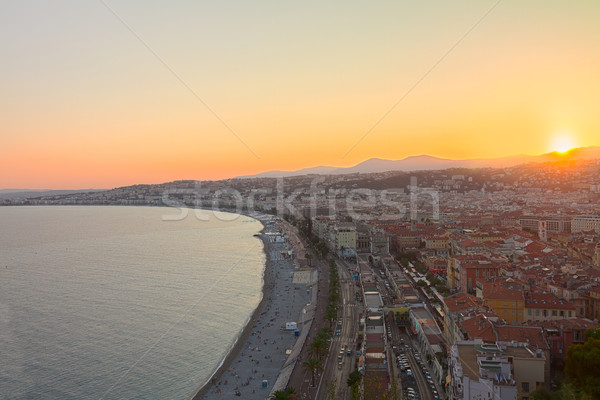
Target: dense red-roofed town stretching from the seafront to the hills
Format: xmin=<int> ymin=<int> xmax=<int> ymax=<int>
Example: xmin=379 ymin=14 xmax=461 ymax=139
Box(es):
xmin=0 ymin=160 xmax=600 ymax=400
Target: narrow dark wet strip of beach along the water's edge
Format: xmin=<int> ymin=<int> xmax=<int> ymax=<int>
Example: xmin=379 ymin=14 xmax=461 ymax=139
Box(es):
xmin=192 ymin=220 xmax=272 ymax=400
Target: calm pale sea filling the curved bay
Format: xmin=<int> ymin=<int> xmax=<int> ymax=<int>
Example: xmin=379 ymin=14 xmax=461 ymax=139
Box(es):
xmin=0 ymin=207 xmax=265 ymax=399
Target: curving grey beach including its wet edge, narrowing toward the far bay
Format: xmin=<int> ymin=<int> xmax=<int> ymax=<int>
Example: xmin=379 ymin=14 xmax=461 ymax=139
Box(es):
xmin=2 ymin=206 xmax=308 ymax=400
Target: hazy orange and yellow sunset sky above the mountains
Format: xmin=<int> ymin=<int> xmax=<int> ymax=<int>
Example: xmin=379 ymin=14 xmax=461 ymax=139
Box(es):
xmin=0 ymin=0 xmax=600 ymax=188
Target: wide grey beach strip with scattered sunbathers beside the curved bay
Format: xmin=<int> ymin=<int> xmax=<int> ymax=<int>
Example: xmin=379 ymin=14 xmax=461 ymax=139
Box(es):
xmin=193 ymin=217 xmax=314 ymax=400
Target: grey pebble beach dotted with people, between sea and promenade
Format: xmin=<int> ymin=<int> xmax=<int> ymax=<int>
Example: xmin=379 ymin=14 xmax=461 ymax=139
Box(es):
xmin=199 ymin=221 xmax=317 ymax=400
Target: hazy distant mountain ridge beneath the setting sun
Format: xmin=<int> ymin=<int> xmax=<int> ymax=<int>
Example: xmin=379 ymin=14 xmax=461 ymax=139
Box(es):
xmin=239 ymin=146 xmax=600 ymax=178
